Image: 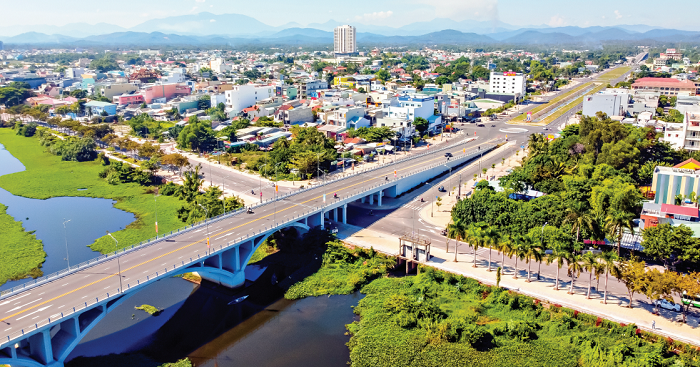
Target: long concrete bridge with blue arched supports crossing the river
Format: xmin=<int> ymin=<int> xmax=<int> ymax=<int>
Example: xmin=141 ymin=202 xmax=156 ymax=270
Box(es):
xmin=0 ymin=138 xmax=495 ymax=367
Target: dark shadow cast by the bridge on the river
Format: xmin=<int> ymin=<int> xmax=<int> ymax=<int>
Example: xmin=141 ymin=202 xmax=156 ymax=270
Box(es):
xmin=66 ymin=233 xmax=325 ymax=367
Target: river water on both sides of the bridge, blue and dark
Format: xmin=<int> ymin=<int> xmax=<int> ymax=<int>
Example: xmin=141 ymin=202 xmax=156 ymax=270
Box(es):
xmin=0 ymin=144 xmax=362 ymax=367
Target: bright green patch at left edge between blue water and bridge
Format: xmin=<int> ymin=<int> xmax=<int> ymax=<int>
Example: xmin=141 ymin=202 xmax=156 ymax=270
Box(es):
xmin=0 ymin=204 xmax=46 ymax=284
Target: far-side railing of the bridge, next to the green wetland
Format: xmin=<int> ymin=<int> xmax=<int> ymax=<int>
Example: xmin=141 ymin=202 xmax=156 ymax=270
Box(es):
xmin=0 ymin=138 xmax=492 ymax=300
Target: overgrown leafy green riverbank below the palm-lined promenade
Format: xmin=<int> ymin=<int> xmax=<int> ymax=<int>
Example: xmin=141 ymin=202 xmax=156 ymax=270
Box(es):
xmin=290 ymin=242 xmax=700 ymax=367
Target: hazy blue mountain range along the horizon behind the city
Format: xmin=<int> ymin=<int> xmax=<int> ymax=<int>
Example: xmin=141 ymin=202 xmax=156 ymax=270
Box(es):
xmin=0 ymin=12 xmax=700 ymax=46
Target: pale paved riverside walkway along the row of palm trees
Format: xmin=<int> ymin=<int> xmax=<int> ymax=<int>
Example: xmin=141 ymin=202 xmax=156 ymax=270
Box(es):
xmin=329 ymin=222 xmax=700 ymax=346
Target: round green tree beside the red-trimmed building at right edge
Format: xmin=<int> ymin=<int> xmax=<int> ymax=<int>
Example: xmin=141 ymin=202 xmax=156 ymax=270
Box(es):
xmin=642 ymin=223 xmax=700 ymax=269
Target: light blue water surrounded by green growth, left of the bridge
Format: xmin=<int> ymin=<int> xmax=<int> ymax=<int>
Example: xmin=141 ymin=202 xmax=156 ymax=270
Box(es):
xmin=0 ymin=144 xmax=136 ymax=290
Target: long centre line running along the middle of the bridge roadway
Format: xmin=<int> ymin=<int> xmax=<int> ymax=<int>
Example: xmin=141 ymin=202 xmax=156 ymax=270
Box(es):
xmin=0 ymin=139 xmax=493 ymax=321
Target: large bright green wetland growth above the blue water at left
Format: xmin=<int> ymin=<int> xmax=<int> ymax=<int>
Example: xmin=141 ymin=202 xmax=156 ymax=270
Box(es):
xmin=0 ymin=129 xmax=183 ymax=253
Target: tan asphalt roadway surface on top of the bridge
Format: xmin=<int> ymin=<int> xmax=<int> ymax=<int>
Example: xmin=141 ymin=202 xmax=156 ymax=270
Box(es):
xmin=0 ymin=131 xmax=484 ymax=343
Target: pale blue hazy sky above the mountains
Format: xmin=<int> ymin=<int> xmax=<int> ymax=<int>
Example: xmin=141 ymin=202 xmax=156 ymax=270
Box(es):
xmin=0 ymin=0 xmax=700 ymax=30
